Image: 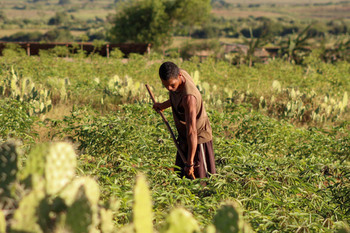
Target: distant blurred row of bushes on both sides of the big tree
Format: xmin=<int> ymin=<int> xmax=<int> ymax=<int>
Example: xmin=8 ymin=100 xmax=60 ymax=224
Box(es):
xmin=0 ymin=12 xmax=350 ymax=42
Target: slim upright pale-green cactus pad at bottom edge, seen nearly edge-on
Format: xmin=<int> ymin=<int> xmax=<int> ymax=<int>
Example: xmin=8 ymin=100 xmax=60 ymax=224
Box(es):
xmin=133 ymin=175 xmax=153 ymax=233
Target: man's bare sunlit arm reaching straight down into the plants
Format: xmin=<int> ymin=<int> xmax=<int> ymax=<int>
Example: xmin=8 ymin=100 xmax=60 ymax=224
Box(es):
xmin=182 ymin=95 xmax=198 ymax=175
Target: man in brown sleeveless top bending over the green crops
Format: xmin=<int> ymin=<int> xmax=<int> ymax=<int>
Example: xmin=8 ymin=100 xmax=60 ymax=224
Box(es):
xmin=153 ymin=62 xmax=216 ymax=178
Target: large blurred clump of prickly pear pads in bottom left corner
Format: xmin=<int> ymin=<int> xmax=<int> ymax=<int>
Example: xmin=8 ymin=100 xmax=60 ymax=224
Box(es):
xmin=0 ymin=143 xmax=119 ymax=233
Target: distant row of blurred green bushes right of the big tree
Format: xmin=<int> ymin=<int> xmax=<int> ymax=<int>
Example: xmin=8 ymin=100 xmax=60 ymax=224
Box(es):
xmin=186 ymin=16 xmax=350 ymax=38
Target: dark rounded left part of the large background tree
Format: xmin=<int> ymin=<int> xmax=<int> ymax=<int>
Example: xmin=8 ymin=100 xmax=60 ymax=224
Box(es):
xmin=111 ymin=0 xmax=171 ymax=47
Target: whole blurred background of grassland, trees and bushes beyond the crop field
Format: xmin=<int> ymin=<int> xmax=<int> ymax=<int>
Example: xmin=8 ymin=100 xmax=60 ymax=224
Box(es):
xmin=0 ymin=0 xmax=350 ymax=66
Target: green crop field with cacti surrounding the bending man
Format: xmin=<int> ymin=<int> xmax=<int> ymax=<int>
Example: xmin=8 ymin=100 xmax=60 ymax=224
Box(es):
xmin=0 ymin=46 xmax=350 ymax=233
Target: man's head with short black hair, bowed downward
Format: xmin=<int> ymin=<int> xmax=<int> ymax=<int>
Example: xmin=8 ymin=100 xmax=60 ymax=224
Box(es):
xmin=159 ymin=62 xmax=182 ymax=91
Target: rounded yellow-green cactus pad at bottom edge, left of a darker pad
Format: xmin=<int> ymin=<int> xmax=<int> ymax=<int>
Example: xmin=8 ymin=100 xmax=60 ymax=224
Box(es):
xmin=161 ymin=208 xmax=200 ymax=233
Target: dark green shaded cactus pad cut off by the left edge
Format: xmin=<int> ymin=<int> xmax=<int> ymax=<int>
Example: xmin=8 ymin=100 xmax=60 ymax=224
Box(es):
xmin=0 ymin=142 xmax=18 ymax=200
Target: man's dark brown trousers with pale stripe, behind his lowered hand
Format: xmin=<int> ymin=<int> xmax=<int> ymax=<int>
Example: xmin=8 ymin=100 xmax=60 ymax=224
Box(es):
xmin=175 ymin=141 xmax=216 ymax=178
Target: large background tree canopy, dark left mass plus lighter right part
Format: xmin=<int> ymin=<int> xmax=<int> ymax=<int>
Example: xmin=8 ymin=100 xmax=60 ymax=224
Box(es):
xmin=110 ymin=0 xmax=211 ymax=47
